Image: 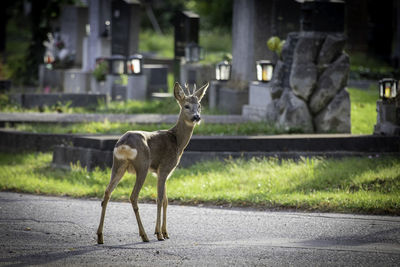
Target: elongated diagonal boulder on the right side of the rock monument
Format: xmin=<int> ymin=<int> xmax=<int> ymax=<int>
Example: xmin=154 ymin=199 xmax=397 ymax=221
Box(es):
xmin=309 ymin=53 xmax=350 ymax=114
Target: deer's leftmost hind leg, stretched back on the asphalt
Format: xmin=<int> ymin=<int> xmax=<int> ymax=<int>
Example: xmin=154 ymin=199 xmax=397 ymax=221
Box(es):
xmin=97 ymin=157 xmax=128 ymax=244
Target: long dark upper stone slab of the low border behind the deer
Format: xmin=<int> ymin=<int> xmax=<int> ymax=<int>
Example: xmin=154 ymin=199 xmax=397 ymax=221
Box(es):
xmin=73 ymin=134 xmax=400 ymax=153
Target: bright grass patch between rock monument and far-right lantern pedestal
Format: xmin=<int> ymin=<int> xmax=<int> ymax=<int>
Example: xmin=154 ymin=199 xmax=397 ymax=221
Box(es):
xmin=347 ymin=88 xmax=378 ymax=134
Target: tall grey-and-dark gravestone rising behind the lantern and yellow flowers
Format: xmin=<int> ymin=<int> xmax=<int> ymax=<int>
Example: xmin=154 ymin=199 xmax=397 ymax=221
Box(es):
xmin=232 ymin=0 xmax=300 ymax=82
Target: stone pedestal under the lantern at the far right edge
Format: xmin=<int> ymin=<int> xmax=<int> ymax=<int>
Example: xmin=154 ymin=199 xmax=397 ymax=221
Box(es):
xmin=374 ymin=100 xmax=400 ymax=135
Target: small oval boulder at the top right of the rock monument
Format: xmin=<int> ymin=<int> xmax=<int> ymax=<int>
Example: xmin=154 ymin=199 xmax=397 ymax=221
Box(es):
xmin=318 ymin=33 xmax=346 ymax=67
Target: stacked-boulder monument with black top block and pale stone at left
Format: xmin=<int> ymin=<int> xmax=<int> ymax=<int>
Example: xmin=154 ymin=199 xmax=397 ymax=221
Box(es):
xmin=243 ymin=1 xmax=351 ymax=133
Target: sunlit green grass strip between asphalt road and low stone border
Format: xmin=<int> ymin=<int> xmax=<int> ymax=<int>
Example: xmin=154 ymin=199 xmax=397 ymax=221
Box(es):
xmin=0 ymin=153 xmax=400 ymax=215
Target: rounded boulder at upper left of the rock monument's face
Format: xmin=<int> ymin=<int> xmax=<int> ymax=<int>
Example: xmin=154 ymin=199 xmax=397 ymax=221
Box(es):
xmin=289 ymin=61 xmax=318 ymax=101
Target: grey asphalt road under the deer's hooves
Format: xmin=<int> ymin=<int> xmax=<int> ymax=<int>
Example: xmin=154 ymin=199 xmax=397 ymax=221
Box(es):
xmin=0 ymin=192 xmax=400 ymax=266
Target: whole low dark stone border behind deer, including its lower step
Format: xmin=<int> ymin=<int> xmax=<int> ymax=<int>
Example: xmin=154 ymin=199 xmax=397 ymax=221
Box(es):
xmin=53 ymin=135 xmax=400 ymax=170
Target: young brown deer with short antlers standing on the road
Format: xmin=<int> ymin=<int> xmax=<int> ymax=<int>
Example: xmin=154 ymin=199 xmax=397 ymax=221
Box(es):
xmin=97 ymin=82 xmax=209 ymax=244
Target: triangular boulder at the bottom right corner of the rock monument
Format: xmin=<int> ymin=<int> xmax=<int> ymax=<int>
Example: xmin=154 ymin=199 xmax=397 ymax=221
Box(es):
xmin=314 ymin=89 xmax=351 ymax=133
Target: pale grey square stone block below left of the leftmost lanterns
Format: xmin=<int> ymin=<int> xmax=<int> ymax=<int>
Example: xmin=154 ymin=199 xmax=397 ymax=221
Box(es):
xmin=64 ymin=69 xmax=91 ymax=93
